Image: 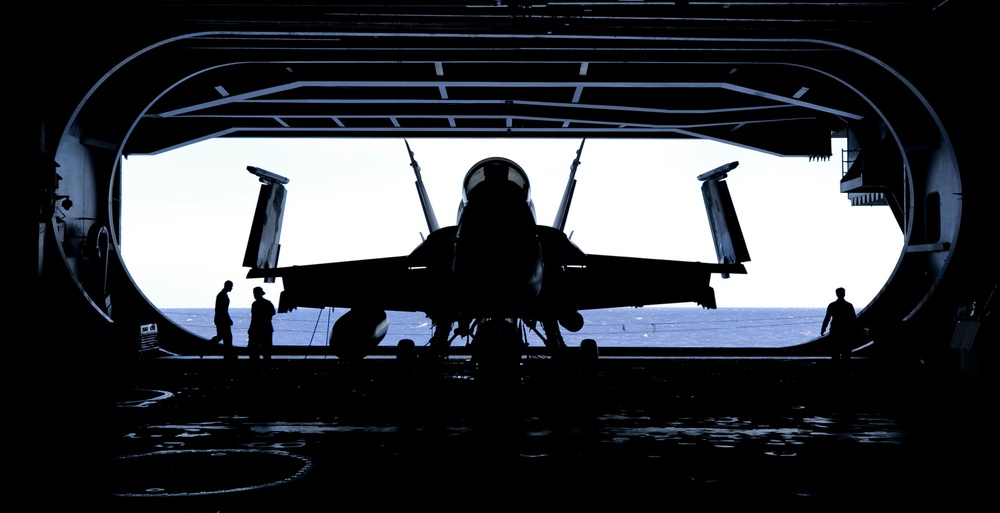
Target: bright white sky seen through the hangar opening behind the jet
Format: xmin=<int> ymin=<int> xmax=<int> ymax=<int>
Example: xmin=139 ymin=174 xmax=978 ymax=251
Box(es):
xmin=119 ymin=138 xmax=903 ymax=309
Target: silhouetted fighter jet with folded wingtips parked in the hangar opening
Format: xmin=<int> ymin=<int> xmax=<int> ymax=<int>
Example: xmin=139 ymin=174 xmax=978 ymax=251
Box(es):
xmin=243 ymin=140 xmax=749 ymax=360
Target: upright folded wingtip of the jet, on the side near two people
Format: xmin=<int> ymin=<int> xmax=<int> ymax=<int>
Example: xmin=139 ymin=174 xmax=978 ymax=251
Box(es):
xmin=243 ymin=166 xmax=288 ymax=283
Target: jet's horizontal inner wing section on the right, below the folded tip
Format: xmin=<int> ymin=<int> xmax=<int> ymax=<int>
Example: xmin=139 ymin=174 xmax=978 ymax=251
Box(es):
xmin=555 ymin=255 xmax=746 ymax=310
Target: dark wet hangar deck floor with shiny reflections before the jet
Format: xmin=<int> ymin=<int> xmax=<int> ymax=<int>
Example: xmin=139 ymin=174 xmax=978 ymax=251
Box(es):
xmin=60 ymin=358 xmax=995 ymax=512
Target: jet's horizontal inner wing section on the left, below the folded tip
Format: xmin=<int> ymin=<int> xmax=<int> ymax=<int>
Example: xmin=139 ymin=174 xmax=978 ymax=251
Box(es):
xmin=247 ymin=256 xmax=441 ymax=313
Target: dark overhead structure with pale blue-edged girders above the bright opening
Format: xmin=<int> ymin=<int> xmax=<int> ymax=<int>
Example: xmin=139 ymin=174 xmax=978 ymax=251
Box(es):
xmin=119 ymin=34 xmax=865 ymax=155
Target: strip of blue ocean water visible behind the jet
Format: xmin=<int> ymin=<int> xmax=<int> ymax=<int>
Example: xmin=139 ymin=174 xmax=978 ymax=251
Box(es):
xmin=160 ymin=306 xmax=825 ymax=348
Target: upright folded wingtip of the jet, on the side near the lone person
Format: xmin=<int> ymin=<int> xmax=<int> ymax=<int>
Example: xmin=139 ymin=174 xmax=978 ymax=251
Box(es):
xmin=698 ymin=162 xmax=750 ymax=278
